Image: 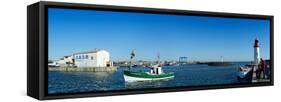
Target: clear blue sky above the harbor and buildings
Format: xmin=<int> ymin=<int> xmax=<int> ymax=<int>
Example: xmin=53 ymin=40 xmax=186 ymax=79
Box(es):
xmin=48 ymin=8 xmax=270 ymax=61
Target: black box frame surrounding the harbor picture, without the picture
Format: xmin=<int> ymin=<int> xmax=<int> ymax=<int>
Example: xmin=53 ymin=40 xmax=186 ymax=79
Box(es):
xmin=27 ymin=1 xmax=274 ymax=100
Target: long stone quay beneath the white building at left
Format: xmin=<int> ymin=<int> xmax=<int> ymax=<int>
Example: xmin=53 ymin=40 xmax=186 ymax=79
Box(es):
xmin=48 ymin=66 xmax=117 ymax=72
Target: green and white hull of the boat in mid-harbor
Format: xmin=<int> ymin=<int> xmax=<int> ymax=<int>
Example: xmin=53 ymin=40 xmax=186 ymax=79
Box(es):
xmin=124 ymin=71 xmax=174 ymax=82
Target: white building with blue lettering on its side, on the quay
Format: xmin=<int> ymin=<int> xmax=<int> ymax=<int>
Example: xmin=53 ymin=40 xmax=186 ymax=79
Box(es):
xmin=73 ymin=50 xmax=112 ymax=67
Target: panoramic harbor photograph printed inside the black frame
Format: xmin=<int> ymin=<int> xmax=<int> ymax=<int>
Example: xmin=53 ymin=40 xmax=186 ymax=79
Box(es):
xmin=48 ymin=8 xmax=271 ymax=94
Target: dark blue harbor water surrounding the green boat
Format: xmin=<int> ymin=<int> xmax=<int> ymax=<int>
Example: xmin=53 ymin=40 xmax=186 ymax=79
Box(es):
xmin=48 ymin=62 xmax=249 ymax=94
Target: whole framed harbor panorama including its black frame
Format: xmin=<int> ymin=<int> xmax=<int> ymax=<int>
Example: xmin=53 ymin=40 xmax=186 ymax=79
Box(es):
xmin=27 ymin=1 xmax=274 ymax=100
